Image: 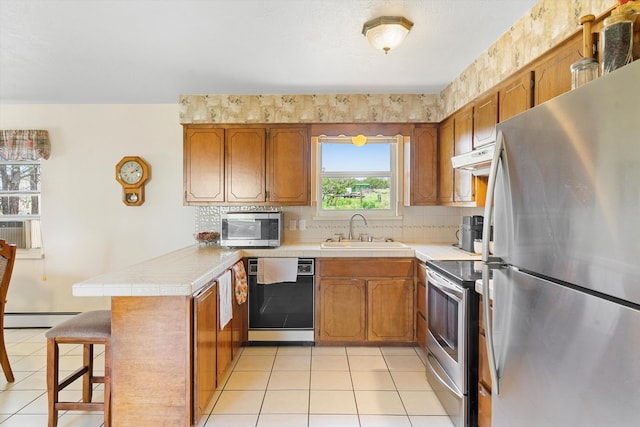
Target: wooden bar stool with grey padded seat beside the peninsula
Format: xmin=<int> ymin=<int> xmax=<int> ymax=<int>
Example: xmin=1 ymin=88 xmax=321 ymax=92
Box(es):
xmin=45 ymin=310 xmax=111 ymax=427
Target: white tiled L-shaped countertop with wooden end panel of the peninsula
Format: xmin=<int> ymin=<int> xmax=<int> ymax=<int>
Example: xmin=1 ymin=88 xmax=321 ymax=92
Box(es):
xmin=73 ymin=243 xmax=480 ymax=426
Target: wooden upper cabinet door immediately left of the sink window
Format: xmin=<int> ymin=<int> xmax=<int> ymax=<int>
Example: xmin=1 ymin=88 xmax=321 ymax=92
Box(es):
xmin=268 ymin=127 xmax=310 ymax=205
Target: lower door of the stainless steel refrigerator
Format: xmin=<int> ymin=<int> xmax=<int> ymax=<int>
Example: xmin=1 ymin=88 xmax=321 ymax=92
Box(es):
xmin=492 ymin=269 xmax=640 ymax=427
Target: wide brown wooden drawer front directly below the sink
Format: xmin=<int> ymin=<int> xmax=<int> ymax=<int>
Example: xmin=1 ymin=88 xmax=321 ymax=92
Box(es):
xmin=317 ymin=258 xmax=413 ymax=278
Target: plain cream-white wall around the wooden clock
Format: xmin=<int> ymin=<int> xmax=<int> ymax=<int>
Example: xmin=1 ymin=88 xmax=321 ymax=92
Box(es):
xmin=0 ymin=104 xmax=195 ymax=313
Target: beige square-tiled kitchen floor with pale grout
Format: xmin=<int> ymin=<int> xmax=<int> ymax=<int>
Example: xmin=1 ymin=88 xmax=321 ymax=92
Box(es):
xmin=0 ymin=329 xmax=453 ymax=427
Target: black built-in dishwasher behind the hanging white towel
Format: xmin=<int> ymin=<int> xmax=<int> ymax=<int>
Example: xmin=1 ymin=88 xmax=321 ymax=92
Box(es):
xmin=247 ymin=258 xmax=315 ymax=344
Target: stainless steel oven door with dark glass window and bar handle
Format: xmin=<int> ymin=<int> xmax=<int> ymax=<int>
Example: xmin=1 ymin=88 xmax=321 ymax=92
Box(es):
xmin=427 ymin=269 xmax=467 ymax=394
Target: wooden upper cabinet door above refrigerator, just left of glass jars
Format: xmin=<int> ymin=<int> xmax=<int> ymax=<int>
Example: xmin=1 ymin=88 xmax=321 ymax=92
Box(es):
xmin=533 ymin=35 xmax=582 ymax=105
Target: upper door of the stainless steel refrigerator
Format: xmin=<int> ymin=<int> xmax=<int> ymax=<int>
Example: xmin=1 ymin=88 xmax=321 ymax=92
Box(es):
xmin=494 ymin=61 xmax=640 ymax=304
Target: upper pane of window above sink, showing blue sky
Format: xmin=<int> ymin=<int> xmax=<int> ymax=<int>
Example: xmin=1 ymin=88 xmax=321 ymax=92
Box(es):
xmin=321 ymin=143 xmax=391 ymax=172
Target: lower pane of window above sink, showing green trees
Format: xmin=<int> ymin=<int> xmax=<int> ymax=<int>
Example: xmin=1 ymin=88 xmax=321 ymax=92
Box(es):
xmin=322 ymin=177 xmax=391 ymax=210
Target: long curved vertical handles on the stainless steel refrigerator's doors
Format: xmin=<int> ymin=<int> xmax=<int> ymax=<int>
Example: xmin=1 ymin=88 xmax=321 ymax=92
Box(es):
xmin=482 ymin=132 xmax=507 ymax=395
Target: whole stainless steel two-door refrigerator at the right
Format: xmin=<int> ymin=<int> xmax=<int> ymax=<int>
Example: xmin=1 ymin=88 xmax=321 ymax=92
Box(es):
xmin=483 ymin=61 xmax=640 ymax=427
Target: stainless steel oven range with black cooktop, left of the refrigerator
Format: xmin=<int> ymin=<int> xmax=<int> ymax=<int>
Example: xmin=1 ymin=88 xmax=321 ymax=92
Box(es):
xmin=426 ymin=261 xmax=480 ymax=427
